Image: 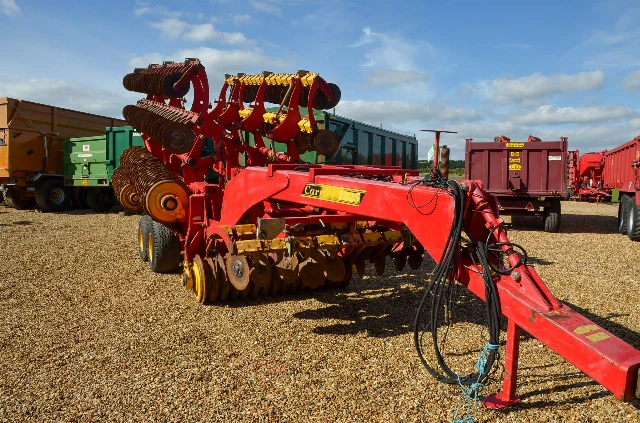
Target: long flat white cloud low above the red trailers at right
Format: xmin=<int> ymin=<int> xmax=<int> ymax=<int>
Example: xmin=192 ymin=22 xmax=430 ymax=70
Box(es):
xmin=514 ymin=105 xmax=638 ymax=125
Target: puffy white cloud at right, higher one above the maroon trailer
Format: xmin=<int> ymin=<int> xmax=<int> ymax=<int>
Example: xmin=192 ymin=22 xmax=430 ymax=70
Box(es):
xmin=484 ymin=71 xmax=604 ymax=103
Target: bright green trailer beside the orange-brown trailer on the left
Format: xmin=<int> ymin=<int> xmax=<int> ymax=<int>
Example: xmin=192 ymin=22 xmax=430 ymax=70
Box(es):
xmin=64 ymin=126 xmax=144 ymax=212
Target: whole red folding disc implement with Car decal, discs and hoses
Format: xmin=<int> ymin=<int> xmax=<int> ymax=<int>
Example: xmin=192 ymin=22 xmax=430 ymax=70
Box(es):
xmin=119 ymin=60 xmax=640 ymax=407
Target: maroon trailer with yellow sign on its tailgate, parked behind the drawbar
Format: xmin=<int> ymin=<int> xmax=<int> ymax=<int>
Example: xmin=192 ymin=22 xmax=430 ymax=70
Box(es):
xmin=465 ymin=136 xmax=568 ymax=232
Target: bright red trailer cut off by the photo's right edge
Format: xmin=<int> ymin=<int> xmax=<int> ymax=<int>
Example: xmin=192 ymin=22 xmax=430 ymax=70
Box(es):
xmin=602 ymin=135 xmax=640 ymax=241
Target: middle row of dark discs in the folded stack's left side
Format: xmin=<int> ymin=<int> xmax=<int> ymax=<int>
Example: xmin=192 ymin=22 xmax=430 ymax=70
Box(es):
xmin=122 ymin=105 xmax=195 ymax=154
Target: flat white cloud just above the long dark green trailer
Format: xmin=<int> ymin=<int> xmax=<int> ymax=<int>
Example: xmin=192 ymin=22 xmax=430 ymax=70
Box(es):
xmin=336 ymin=100 xmax=481 ymax=125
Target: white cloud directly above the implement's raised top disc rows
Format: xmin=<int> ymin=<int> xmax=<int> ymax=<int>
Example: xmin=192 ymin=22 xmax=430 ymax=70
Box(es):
xmin=129 ymin=47 xmax=289 ymax=81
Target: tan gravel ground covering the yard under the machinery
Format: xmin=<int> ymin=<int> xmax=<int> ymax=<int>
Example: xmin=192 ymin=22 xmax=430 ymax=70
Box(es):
xmin=0 ymin=203 xmax=640 ymax=422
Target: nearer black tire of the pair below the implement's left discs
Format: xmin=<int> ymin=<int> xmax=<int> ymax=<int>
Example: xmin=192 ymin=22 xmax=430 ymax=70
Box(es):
xmin=147 ymin=221 xmax=182 ymax=273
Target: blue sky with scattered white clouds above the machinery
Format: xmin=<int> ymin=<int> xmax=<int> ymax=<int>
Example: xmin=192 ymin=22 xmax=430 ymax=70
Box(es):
xmin=0 ymin=0 xmax=640 ymax=158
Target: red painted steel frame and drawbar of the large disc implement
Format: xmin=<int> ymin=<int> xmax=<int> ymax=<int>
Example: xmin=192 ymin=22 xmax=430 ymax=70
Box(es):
xmin=119 ymin=58 xmax=640 ymax=408
